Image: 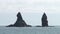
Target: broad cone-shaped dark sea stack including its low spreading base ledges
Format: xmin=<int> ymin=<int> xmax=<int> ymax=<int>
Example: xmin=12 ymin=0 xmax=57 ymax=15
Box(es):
xmin=7 ymin=12 xmax=31 ymax=27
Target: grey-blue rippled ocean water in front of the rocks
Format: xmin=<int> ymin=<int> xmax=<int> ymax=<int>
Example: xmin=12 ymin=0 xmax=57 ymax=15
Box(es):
xmin=0 ymin=27 xmax=60 ymax=34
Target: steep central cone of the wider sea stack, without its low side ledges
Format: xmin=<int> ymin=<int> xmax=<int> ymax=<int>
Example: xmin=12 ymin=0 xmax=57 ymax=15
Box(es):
xmin=14 ymin=12 xmax=27 ymax=27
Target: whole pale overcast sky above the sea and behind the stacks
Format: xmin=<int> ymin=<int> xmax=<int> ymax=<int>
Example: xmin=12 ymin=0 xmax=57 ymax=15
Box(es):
xmin=0 ymin=0 xmax=60 ymax=25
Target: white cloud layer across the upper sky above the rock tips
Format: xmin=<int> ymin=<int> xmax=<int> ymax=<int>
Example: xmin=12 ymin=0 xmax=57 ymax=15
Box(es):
xmin=0 ymin=0 xmax=60 ymax=13
